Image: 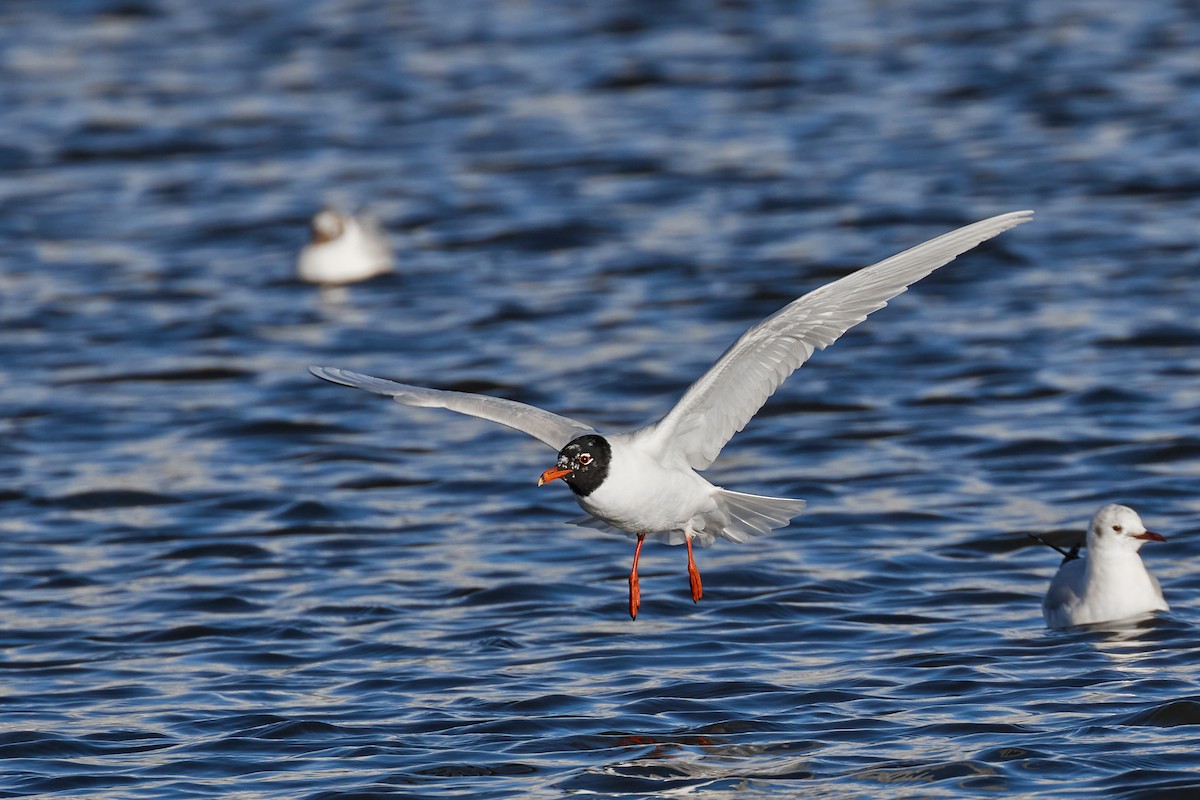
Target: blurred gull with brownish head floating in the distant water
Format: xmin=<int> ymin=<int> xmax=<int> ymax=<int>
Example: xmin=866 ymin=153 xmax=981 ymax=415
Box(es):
xmin=296 ymin=209 xmax=392 ymax=284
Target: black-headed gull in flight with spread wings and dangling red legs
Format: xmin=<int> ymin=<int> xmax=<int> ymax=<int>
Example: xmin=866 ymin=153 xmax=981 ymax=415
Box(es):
xmin=311 ymin=211 xmax=1032 ymax=615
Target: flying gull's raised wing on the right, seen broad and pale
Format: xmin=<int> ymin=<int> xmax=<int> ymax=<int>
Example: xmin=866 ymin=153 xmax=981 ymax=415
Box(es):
xmin=637 ymin=211 xmax=1033 ymax=469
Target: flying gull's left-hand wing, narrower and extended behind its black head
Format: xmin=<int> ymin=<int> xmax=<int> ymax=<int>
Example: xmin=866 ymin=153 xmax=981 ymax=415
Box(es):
xmin=308 ymin=367 xmax=595 ymax=450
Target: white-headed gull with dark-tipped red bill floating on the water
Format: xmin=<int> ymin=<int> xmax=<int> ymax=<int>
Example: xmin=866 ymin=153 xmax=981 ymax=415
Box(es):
xmin=1034 ymin=503 xmax=1168 ymax=628
